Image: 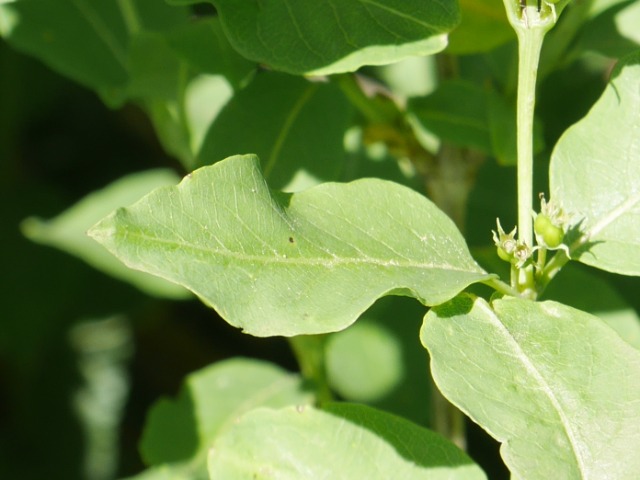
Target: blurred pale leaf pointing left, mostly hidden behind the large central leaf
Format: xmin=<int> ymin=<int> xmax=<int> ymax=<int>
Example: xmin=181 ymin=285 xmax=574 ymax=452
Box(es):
xmin=22 ymin=170 xmax=189 ymax=299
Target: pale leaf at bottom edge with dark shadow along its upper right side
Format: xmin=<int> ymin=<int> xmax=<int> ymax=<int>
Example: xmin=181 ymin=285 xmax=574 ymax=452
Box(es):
xmin=209 ymin=404 xmax=486 ymax=480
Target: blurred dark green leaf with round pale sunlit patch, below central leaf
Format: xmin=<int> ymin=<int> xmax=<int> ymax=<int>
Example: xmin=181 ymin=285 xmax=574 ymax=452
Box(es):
xmin=325 ymin=297 xmax=430 ymax=425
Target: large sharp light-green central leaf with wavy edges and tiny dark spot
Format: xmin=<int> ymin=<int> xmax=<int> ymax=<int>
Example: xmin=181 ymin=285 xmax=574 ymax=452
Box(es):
xmin=90 ymin=155 xmax=490 ymax=336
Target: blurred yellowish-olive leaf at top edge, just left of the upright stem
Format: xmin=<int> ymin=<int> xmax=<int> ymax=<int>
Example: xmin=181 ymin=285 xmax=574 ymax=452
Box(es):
xmin=447 ymin=0 xmax=515 ymax=55
